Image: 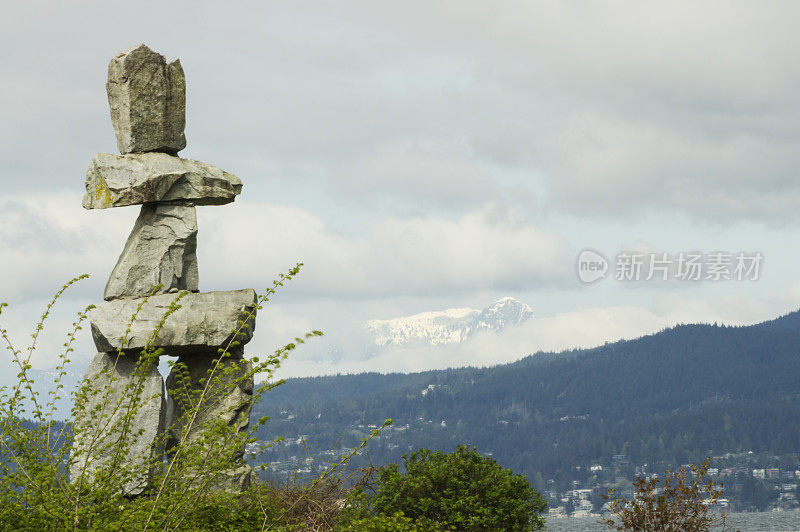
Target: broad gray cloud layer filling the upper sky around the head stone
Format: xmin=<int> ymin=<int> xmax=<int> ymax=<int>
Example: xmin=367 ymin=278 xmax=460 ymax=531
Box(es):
xmin=0 ymin=2 xmax=800 ymax=222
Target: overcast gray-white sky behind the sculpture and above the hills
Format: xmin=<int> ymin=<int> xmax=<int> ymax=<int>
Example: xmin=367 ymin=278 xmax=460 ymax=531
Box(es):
xmin=0 ymin=1 xmax=800 ymax=382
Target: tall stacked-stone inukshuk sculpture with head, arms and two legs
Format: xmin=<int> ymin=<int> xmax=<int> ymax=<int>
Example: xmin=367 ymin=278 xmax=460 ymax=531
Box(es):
xmin=70 ymin=44 xmax=256 ymax=495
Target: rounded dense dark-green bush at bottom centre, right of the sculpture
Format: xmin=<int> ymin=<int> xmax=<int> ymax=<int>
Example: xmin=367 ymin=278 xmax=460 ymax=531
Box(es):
xmin=358 ymin=446 xmax=547 ymax=531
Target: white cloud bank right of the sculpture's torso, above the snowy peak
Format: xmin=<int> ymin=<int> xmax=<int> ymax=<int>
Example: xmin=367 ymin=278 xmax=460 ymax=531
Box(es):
xmin=198 ymin=202 xmax=572 ymax=298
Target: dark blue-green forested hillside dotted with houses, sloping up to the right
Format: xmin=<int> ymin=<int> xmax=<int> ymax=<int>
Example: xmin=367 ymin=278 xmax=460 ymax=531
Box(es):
xmin=257 ymin=312 xmax=800 ymax=492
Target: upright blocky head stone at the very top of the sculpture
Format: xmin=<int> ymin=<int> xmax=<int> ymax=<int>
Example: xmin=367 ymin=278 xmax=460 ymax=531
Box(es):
xmin=106 ymin=44 xmax=186 ymax=153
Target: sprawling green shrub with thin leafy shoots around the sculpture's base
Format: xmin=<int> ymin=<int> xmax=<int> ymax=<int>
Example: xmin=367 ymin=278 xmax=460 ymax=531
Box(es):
xmin=0 ymin=272 xmax=321 ymax=530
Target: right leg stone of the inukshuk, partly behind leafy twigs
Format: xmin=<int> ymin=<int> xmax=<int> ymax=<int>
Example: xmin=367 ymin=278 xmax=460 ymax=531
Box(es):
xmin=166 ymin=348 xmax=254 ymax=491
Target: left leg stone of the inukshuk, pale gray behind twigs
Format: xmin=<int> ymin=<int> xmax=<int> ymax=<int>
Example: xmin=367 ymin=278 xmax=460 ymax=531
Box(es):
xmin=69 ymin=353 xmax=166 ymax=495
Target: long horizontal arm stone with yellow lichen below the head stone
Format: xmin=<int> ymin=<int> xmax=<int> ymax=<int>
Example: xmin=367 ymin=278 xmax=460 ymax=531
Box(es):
xmin=83 ymin=153 xmax=242 ymax=209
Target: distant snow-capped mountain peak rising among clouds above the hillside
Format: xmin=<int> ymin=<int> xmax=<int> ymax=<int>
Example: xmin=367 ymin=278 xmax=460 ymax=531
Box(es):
xmin=367 ymin=297 xmax=533 ymax=346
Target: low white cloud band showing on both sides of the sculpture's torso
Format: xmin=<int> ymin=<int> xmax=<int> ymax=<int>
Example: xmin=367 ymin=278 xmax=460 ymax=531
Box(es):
xmin=0 ymin=193 xmax=572 ymax=301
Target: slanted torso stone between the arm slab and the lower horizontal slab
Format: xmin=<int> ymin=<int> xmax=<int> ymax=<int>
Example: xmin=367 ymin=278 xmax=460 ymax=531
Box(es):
xmin=105 ymin=203 xmax=198 ymax=301
